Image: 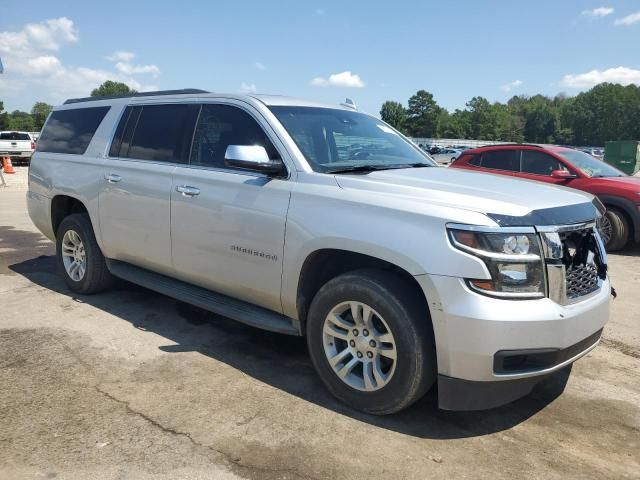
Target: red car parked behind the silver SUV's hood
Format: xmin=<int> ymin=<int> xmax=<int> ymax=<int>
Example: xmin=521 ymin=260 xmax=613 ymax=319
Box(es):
xmin=450 ymin=144 xmax=640 ymax=251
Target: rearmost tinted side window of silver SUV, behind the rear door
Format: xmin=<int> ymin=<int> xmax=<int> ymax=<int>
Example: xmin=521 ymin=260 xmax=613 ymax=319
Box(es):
xmin=36 ymin=107 xmax=111 ymax=155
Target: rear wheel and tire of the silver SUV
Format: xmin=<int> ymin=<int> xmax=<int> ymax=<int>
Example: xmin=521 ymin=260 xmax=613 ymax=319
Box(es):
xmin=56 ymin=213 xmax=113 ymax=294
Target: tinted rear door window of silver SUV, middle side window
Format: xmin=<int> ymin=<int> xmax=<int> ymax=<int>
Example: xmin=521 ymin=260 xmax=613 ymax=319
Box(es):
xmin=109 ymin=104 xmax=200 ymax=163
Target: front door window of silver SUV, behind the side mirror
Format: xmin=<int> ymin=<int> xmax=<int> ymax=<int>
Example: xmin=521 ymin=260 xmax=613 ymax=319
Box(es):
xmin=189 ymin=104 xmax=280 ymax=168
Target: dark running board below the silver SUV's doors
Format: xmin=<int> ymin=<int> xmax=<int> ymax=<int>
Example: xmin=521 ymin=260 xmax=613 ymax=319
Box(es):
xmin=106 ymin=259 xmax=301 ymax=335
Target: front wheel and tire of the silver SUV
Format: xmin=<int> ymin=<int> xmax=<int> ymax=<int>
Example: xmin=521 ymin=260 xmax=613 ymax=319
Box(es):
xmin=307 ymin=270 xmax=436 ymax=415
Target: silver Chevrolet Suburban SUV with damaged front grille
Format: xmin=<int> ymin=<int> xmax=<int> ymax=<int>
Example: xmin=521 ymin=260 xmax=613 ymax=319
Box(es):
xmin=28 ymin=89 xmax=611 ymax=414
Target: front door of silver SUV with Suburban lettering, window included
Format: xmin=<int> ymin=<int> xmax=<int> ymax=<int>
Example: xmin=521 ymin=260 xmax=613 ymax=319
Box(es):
xmin=171 ymin=101 xmax=292 ymax=311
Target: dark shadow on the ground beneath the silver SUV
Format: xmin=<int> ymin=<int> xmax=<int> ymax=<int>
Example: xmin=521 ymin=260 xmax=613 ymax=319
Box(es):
xmin=9 ymin=251 xmax=570 ymax=439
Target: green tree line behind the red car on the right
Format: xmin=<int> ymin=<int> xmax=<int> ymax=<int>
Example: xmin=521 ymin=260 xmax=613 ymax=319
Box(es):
xmin=380 ymin=83 xmax=640 ymax=145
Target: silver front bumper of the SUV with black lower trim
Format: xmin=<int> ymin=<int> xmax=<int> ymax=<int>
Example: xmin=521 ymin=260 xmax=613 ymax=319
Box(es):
xmin=416 ymin=275 xmax=611 ymax=410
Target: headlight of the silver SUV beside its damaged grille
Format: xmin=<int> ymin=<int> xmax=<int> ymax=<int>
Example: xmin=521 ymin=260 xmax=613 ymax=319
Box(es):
xmin=449 ymin=228 xmax=545 ymax=299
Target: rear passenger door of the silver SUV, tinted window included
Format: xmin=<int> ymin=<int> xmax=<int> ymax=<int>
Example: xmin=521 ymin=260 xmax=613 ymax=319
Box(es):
xmin=99 ymin=104 xmax=199 ymax=274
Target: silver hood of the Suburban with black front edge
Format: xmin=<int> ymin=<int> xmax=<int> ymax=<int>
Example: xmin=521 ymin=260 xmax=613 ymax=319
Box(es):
xmin=336 ymin=167 xmax=595 ymax=223
